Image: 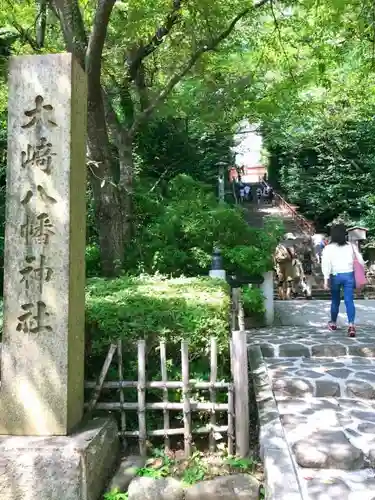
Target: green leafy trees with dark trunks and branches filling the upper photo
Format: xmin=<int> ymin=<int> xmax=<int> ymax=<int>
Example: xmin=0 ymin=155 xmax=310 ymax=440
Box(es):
xmin=0 ymin=0 xmax=375 ymax=270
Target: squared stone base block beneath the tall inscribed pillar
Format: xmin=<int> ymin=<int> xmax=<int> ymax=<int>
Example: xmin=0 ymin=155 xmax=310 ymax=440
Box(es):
xmin=0 ymin=419 xmax=119 ymax=500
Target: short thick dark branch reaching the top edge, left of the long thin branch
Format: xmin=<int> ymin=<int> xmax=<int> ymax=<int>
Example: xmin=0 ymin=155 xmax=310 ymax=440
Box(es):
xmin=126 ymin=0 xmax=183 ymax=80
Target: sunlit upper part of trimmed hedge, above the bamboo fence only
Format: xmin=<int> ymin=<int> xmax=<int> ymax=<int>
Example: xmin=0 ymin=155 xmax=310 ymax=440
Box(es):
xmin=86 ymin=276 xmax=230 ymax=355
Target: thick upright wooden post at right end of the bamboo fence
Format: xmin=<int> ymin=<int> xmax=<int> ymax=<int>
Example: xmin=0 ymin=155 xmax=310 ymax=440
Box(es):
xmin=231 ymin=330 xmax=250 ymax=458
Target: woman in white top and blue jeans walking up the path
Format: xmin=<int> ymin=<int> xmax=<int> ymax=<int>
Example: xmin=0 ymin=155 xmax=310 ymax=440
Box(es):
xmin=322 ymin=224 xmax=364 ymax=337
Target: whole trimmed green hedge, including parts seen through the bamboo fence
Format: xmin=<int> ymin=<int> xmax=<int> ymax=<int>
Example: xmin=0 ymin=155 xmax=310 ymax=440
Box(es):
xmin=85 ymin=276 xmax=230 ymax=429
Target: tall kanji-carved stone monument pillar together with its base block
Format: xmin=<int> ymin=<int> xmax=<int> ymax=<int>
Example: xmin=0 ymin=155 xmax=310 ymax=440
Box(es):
xmin=0 ymin=54 xmax=119 ymax=500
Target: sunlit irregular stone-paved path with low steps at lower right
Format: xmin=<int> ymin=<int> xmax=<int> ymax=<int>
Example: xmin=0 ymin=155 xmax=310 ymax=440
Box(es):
xmin=248 ymin=327 xmax=375 ymax=500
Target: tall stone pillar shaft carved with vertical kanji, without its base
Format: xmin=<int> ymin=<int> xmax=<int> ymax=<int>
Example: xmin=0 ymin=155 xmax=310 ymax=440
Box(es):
xmin=0 ymin=54 xmax=86 ymax=435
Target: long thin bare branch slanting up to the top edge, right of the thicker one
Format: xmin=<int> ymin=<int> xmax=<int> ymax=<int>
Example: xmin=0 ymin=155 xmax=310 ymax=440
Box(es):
xmin=130 ymin=0 xmax=269 ymax=134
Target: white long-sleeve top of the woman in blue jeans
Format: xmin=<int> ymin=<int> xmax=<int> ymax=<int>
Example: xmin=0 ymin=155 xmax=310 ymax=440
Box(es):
xmin=322 ymin=243 xmax=364 ymax=280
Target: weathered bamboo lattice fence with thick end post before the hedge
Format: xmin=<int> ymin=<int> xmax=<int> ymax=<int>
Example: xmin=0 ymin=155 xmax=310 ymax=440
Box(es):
xmin=85 ymin=331 xmax=249 ymax=457
